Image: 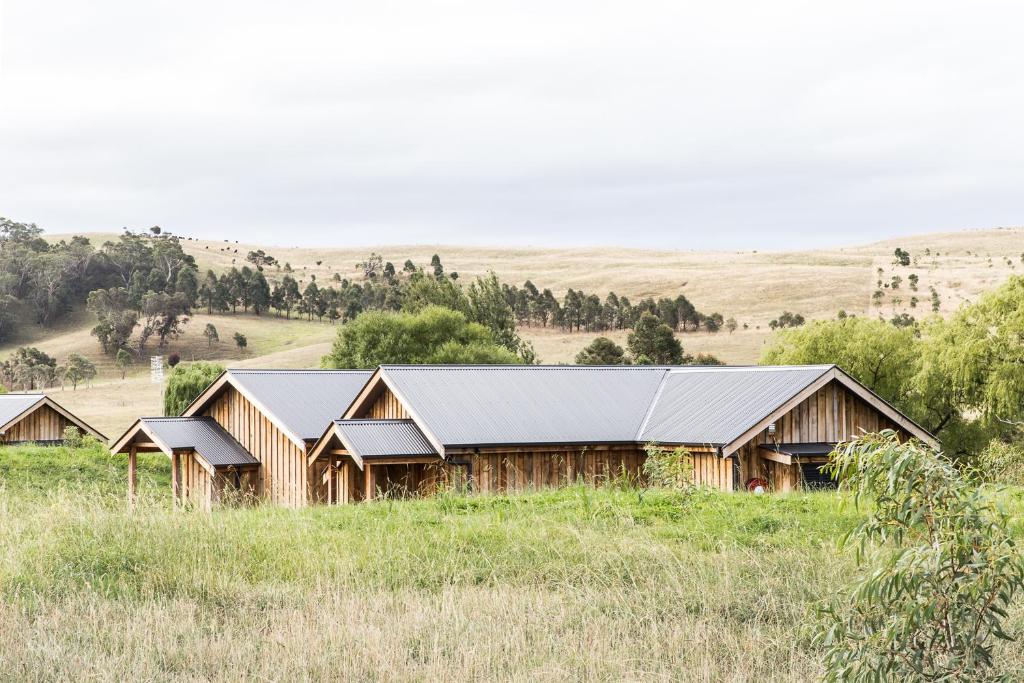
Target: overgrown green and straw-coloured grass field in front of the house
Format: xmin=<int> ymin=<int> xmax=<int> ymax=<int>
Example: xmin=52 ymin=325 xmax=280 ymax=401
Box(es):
xmin=0 ymin=447 xmax=1024 ymax=681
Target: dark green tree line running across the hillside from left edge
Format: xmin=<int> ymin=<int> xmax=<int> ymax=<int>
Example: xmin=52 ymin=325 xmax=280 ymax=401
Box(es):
xmin=0 ymin=218 xmax=735 ymax=368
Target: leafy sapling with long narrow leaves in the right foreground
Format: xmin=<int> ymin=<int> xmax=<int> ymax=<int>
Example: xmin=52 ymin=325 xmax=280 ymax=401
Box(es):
xmin=815 ymin=430 xmax=1024 ymax=681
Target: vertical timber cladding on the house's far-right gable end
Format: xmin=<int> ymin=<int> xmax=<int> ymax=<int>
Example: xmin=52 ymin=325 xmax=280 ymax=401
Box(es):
xmin=736 ymin=381 xmax=907 ymax=490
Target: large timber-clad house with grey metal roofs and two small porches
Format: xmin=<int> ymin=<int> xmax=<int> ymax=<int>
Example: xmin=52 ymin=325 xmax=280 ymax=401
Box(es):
xmin=112 ymin=366 xmax=936 ymax=507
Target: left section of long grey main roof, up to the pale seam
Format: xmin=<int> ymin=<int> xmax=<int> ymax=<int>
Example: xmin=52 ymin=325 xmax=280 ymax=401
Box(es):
xmin=381 ymin=366 xmax=667 ymax=446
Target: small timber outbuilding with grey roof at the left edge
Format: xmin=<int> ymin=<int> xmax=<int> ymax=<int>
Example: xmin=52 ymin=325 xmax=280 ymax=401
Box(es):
xmin=0 ymin=393 xmax=106 ymax=444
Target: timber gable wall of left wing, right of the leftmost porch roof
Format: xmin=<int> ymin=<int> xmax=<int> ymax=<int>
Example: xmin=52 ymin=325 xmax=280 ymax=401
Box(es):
xmin=204 ymin=384 xmax=308 ymax=507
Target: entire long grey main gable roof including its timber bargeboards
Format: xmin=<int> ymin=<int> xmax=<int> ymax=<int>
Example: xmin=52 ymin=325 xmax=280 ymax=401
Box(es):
xmin=345 ymin=366 xmax=936 ymax=456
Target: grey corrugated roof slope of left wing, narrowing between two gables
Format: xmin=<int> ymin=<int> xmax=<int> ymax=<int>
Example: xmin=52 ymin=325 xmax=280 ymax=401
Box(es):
xmin=227 ymin=370 xmax=373 ymax=440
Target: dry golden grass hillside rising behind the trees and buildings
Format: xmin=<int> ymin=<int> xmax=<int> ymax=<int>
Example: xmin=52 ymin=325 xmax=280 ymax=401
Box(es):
xmin=18 ymin=228 xmax=1024 ymax=435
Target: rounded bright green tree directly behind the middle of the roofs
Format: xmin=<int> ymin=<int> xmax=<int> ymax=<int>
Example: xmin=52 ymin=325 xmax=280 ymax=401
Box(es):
xmin=321 ymin=306 xmax=522 ymax=368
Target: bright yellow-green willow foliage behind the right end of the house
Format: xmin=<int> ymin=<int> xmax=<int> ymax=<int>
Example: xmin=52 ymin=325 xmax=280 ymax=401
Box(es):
xmin=762 ymin=276 xmax=1024 ymax=456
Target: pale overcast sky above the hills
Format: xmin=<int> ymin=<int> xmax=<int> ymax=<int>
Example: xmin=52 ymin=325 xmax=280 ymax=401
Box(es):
xmin=0 ymin=0 xmax=1024 ymax=249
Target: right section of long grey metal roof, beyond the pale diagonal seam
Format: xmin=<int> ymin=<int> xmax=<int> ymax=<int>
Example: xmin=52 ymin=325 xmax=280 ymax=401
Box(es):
xmin=638 ymin=366 xmax=834 ymax=445
